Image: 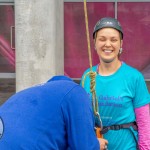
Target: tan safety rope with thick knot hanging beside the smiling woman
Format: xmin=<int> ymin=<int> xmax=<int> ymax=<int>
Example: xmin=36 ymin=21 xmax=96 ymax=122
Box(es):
xmin=82 ymin=0 xmax=102 ymax=132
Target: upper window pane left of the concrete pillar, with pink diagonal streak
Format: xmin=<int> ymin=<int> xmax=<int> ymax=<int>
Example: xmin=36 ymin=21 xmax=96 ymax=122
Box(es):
xmin=0 ymin=5 xmax=15 ymax=73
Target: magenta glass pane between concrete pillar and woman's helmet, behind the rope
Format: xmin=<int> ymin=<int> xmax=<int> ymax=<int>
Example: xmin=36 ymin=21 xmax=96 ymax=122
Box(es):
xmin=64 ymin=2 xmax=114 ymax=78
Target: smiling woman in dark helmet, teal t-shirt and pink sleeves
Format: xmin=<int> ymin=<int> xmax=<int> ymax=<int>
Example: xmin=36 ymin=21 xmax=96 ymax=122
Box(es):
xmin=81 ymin=17 xmax=150 ymax=150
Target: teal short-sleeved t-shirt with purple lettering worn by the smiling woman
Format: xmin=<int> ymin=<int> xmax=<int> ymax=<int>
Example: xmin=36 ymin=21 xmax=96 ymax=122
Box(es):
xmin=81 ymin=62 xmax=150 ymax=150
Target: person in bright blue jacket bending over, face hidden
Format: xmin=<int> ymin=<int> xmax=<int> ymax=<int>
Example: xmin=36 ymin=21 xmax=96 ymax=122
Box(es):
xmin=0 ymin=76 xmax=107 ymax=150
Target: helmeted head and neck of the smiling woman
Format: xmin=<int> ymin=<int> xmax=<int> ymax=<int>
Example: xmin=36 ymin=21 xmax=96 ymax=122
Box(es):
xmin=93 ymin=17 xmax=123 ymax=75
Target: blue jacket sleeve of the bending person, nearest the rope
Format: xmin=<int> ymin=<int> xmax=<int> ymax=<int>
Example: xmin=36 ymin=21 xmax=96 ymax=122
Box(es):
xmin=62 ymin=85 xmax=100 ymax=150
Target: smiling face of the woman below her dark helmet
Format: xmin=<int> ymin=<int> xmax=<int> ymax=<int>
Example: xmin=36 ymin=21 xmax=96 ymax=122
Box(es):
xmin=94 ymin=28 xmax=122 ymax=65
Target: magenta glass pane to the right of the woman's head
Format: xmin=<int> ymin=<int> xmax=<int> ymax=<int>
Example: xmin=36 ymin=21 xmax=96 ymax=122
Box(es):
xmin=118 ymin=2 xmax=150 ymax=79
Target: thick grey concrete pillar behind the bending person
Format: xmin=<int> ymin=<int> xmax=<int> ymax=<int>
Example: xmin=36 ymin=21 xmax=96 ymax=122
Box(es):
xmin=15 ymin=0 xmax=64 ymax=91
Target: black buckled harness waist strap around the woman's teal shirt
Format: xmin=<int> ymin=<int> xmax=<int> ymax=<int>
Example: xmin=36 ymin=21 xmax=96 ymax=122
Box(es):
xmin=101 ymin=122 xmax=138 ymax=134
